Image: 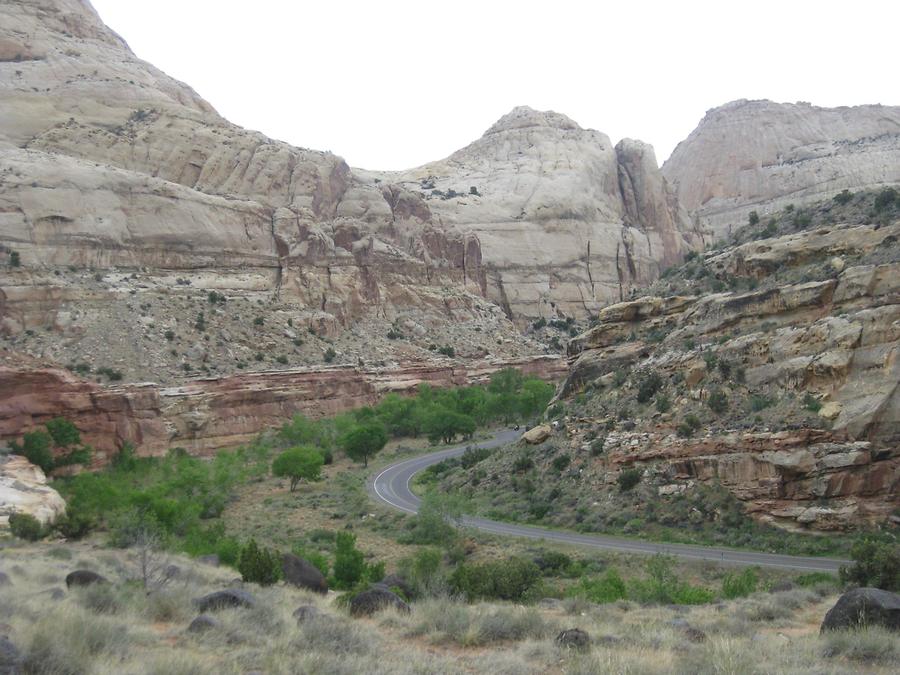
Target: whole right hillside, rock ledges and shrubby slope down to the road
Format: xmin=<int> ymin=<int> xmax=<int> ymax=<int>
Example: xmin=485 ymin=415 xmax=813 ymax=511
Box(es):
xmin=432 ymin=194 xmax=900 ymax=532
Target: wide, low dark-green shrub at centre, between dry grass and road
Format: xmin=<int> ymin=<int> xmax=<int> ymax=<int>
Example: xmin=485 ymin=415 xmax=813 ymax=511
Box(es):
xmin=450 ymin=558 xmax=541 ymax=601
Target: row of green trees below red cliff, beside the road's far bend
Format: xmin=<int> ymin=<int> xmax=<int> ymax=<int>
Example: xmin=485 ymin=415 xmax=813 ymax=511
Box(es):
xmin=274 ymin=368 xmax=553 ymax=470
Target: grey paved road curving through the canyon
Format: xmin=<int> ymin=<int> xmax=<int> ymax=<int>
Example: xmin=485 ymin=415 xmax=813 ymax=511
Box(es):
xmin=367 ymin=430 xmax=848 ymax=572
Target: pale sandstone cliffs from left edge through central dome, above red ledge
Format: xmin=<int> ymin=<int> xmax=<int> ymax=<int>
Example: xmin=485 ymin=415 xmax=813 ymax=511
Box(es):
xmin=0 ymin=0 xmax=695 ymax=396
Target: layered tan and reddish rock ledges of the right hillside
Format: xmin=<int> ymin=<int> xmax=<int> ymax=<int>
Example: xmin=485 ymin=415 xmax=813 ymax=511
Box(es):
xmin=560 ymin=222 xmax=900 ymax=530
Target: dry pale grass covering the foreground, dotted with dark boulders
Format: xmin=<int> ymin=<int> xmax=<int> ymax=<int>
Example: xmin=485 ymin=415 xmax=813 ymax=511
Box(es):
xmin=0 ymin=543 xmax=900 ymax=675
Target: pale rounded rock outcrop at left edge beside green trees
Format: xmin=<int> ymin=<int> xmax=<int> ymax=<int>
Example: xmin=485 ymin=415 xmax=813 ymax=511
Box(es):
xmin=0 ymin=455 xmax=66 ymax=529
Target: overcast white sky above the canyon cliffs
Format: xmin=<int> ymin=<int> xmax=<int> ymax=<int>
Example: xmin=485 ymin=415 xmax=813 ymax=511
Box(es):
xmin=92 ymin=0 xmax=900 ymax=170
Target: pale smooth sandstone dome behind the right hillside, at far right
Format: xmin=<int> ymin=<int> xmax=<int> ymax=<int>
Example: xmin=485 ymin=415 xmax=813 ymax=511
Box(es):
xmin=662 ymin=100 xmax=900 ymax=238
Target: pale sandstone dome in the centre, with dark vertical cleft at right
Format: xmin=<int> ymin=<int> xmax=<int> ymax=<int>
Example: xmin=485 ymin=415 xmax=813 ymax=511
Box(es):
xmin=383 ymin=107 xmax=699 ymax=317
